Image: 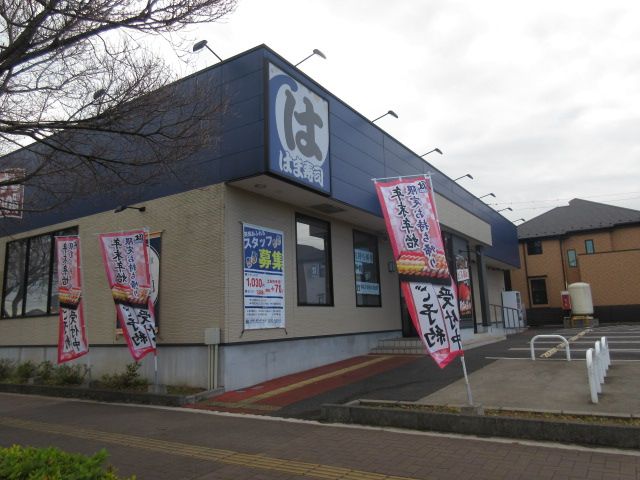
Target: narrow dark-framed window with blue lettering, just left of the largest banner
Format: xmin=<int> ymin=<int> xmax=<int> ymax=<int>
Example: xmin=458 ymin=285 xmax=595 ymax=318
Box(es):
xmin=353 ymin=230 xmax=381 ymax=307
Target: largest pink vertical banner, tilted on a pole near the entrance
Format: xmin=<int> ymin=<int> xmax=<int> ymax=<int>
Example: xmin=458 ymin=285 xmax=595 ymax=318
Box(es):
xmin=374 ymin=176 xmax=463 ymax=368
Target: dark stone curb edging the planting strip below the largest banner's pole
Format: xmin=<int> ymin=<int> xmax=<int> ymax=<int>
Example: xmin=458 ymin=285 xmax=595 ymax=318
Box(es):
xmin=320 ymin=400 xmax=640 ymax=449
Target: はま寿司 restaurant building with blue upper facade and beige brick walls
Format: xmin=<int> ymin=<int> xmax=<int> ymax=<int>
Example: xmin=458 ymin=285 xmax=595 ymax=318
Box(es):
xmin=0 ymin=46 xmax=519 ymax=389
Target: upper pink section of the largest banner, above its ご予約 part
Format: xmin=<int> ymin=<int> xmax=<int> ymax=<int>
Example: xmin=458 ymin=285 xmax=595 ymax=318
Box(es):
xmin=375 ymin=176 xmax=449 ymax=284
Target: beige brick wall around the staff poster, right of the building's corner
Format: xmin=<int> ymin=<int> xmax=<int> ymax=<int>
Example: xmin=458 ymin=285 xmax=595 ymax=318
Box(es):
xmin=224 ymin=187 xmax=401 ymax=348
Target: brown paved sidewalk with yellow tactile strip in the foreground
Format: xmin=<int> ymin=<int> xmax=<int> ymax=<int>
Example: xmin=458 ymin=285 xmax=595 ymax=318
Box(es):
xmin=0 ymin=394 xmax=640 ymax=480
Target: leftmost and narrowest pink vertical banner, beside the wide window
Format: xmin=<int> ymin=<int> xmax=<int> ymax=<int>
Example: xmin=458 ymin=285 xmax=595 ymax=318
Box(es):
xmin=56 ymin=236 xmax=89 ymax=363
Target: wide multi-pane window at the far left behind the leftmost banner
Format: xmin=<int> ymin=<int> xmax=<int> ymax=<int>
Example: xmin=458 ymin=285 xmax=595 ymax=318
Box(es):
xmin=2 ymin=228 xmax=78 ymax=318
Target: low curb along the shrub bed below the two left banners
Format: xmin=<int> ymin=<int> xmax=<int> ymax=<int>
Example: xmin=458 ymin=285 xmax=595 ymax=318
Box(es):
xmin=0 ymin=383 xmax=223 ymax=407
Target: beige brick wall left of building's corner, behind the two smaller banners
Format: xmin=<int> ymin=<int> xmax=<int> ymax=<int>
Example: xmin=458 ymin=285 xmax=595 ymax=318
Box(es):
xmin=0 ymin=184 xmax=224 ymax=345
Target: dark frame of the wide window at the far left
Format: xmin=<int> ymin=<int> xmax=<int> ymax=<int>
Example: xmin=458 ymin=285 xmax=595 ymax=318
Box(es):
xmin=0 ymin=227 xmax=78 ymax=320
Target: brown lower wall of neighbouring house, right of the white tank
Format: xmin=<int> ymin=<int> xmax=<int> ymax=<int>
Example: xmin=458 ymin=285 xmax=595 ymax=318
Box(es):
xmin=578 ymin=249 xmax=640 ymax=305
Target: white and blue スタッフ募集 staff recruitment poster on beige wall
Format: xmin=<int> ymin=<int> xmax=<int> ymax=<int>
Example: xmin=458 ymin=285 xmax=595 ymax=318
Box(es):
xmin=242 ymin=223 xmax=285 ymax=330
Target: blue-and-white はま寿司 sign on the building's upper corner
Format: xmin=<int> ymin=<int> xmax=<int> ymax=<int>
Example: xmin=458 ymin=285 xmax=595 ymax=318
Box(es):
xmin=268 ymin=63 xmax=331 ymax=193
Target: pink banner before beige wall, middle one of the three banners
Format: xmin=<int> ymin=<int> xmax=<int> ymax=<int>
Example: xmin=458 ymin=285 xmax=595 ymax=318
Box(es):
xmin=98 ymin=230 xmax=156 ymax=361
